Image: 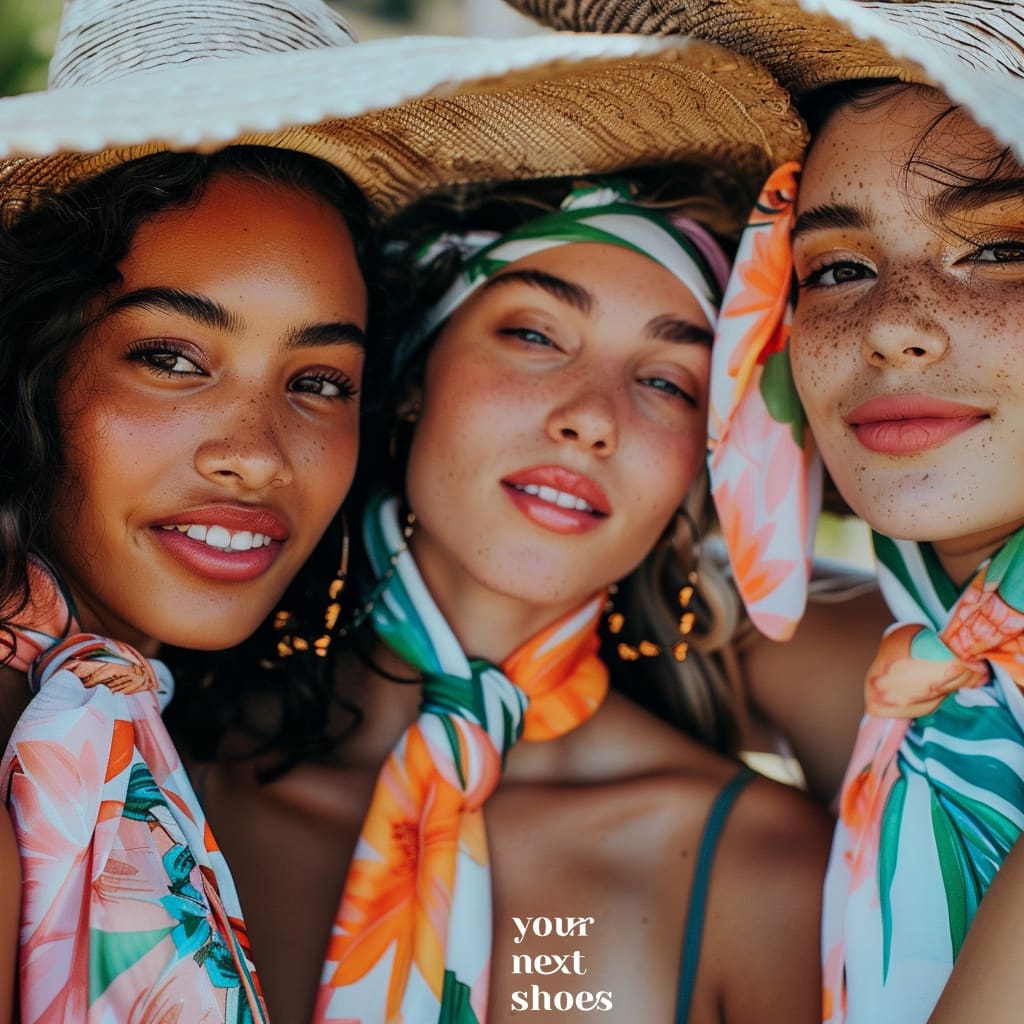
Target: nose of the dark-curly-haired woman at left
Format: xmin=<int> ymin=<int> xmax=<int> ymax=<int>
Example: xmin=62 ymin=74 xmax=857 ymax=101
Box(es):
xmin=194 ymin=395 xmax=292 ymax=490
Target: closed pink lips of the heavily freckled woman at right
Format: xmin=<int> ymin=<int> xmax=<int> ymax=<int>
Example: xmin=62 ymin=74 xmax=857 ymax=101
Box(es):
xmin=846 ymin=394 xmax=988 ymax=455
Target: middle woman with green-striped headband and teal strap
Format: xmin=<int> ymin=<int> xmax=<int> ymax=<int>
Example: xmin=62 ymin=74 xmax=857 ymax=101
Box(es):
xmin=311 ymin=176 xmax=827 ymax=1022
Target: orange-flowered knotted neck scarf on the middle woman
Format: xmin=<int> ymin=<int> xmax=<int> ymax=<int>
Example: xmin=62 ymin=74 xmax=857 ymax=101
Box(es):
xmin=317 ymin=498 xmax=608 ymax=1024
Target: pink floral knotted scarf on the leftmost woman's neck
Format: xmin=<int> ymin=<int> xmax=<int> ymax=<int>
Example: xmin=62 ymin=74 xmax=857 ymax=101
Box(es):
xmin=0 ymin=560 xmax=265 ymax=1024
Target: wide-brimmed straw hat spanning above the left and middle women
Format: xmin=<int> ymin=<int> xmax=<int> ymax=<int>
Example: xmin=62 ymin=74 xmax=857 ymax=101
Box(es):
xmin=0 ymin=0 xmax=805 ymax=213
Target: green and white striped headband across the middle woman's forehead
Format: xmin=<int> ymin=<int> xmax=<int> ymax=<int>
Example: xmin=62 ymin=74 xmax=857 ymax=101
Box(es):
xmin=401 ymin=180 xmax=729 ymax=353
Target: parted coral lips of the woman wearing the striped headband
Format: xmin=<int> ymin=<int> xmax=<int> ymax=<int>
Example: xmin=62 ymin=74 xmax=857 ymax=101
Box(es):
xmin=502 ymin=466 xmax=611 ymax=534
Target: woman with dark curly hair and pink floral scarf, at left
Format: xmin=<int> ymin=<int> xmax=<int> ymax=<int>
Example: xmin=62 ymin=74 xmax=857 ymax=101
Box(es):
xmin=0 ymin=146 xmax=376 ymax=1020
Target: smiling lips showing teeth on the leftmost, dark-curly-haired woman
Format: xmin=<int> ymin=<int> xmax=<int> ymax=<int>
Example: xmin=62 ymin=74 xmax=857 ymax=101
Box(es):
xmin=153 ymin=505 xmax=289 ymax=583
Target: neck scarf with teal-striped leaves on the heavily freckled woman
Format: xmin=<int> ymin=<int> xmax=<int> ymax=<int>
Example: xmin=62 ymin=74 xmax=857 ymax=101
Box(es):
xmin=824 ymin=530 xmax=1024 ymax=1024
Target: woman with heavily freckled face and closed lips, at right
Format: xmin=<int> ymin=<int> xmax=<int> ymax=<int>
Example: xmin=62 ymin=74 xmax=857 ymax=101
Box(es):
xmin=713 ymin=32 xmax=1024 ymax=1024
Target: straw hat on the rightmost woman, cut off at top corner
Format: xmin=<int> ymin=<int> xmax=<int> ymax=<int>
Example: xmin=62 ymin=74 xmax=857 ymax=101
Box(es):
xmin=508 ymin=0 xmax=1024 ymax=159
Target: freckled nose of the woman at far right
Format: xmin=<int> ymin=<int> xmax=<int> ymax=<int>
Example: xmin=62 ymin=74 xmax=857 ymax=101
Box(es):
xmin=861 ymin=279 xmax=949 ymax=369
